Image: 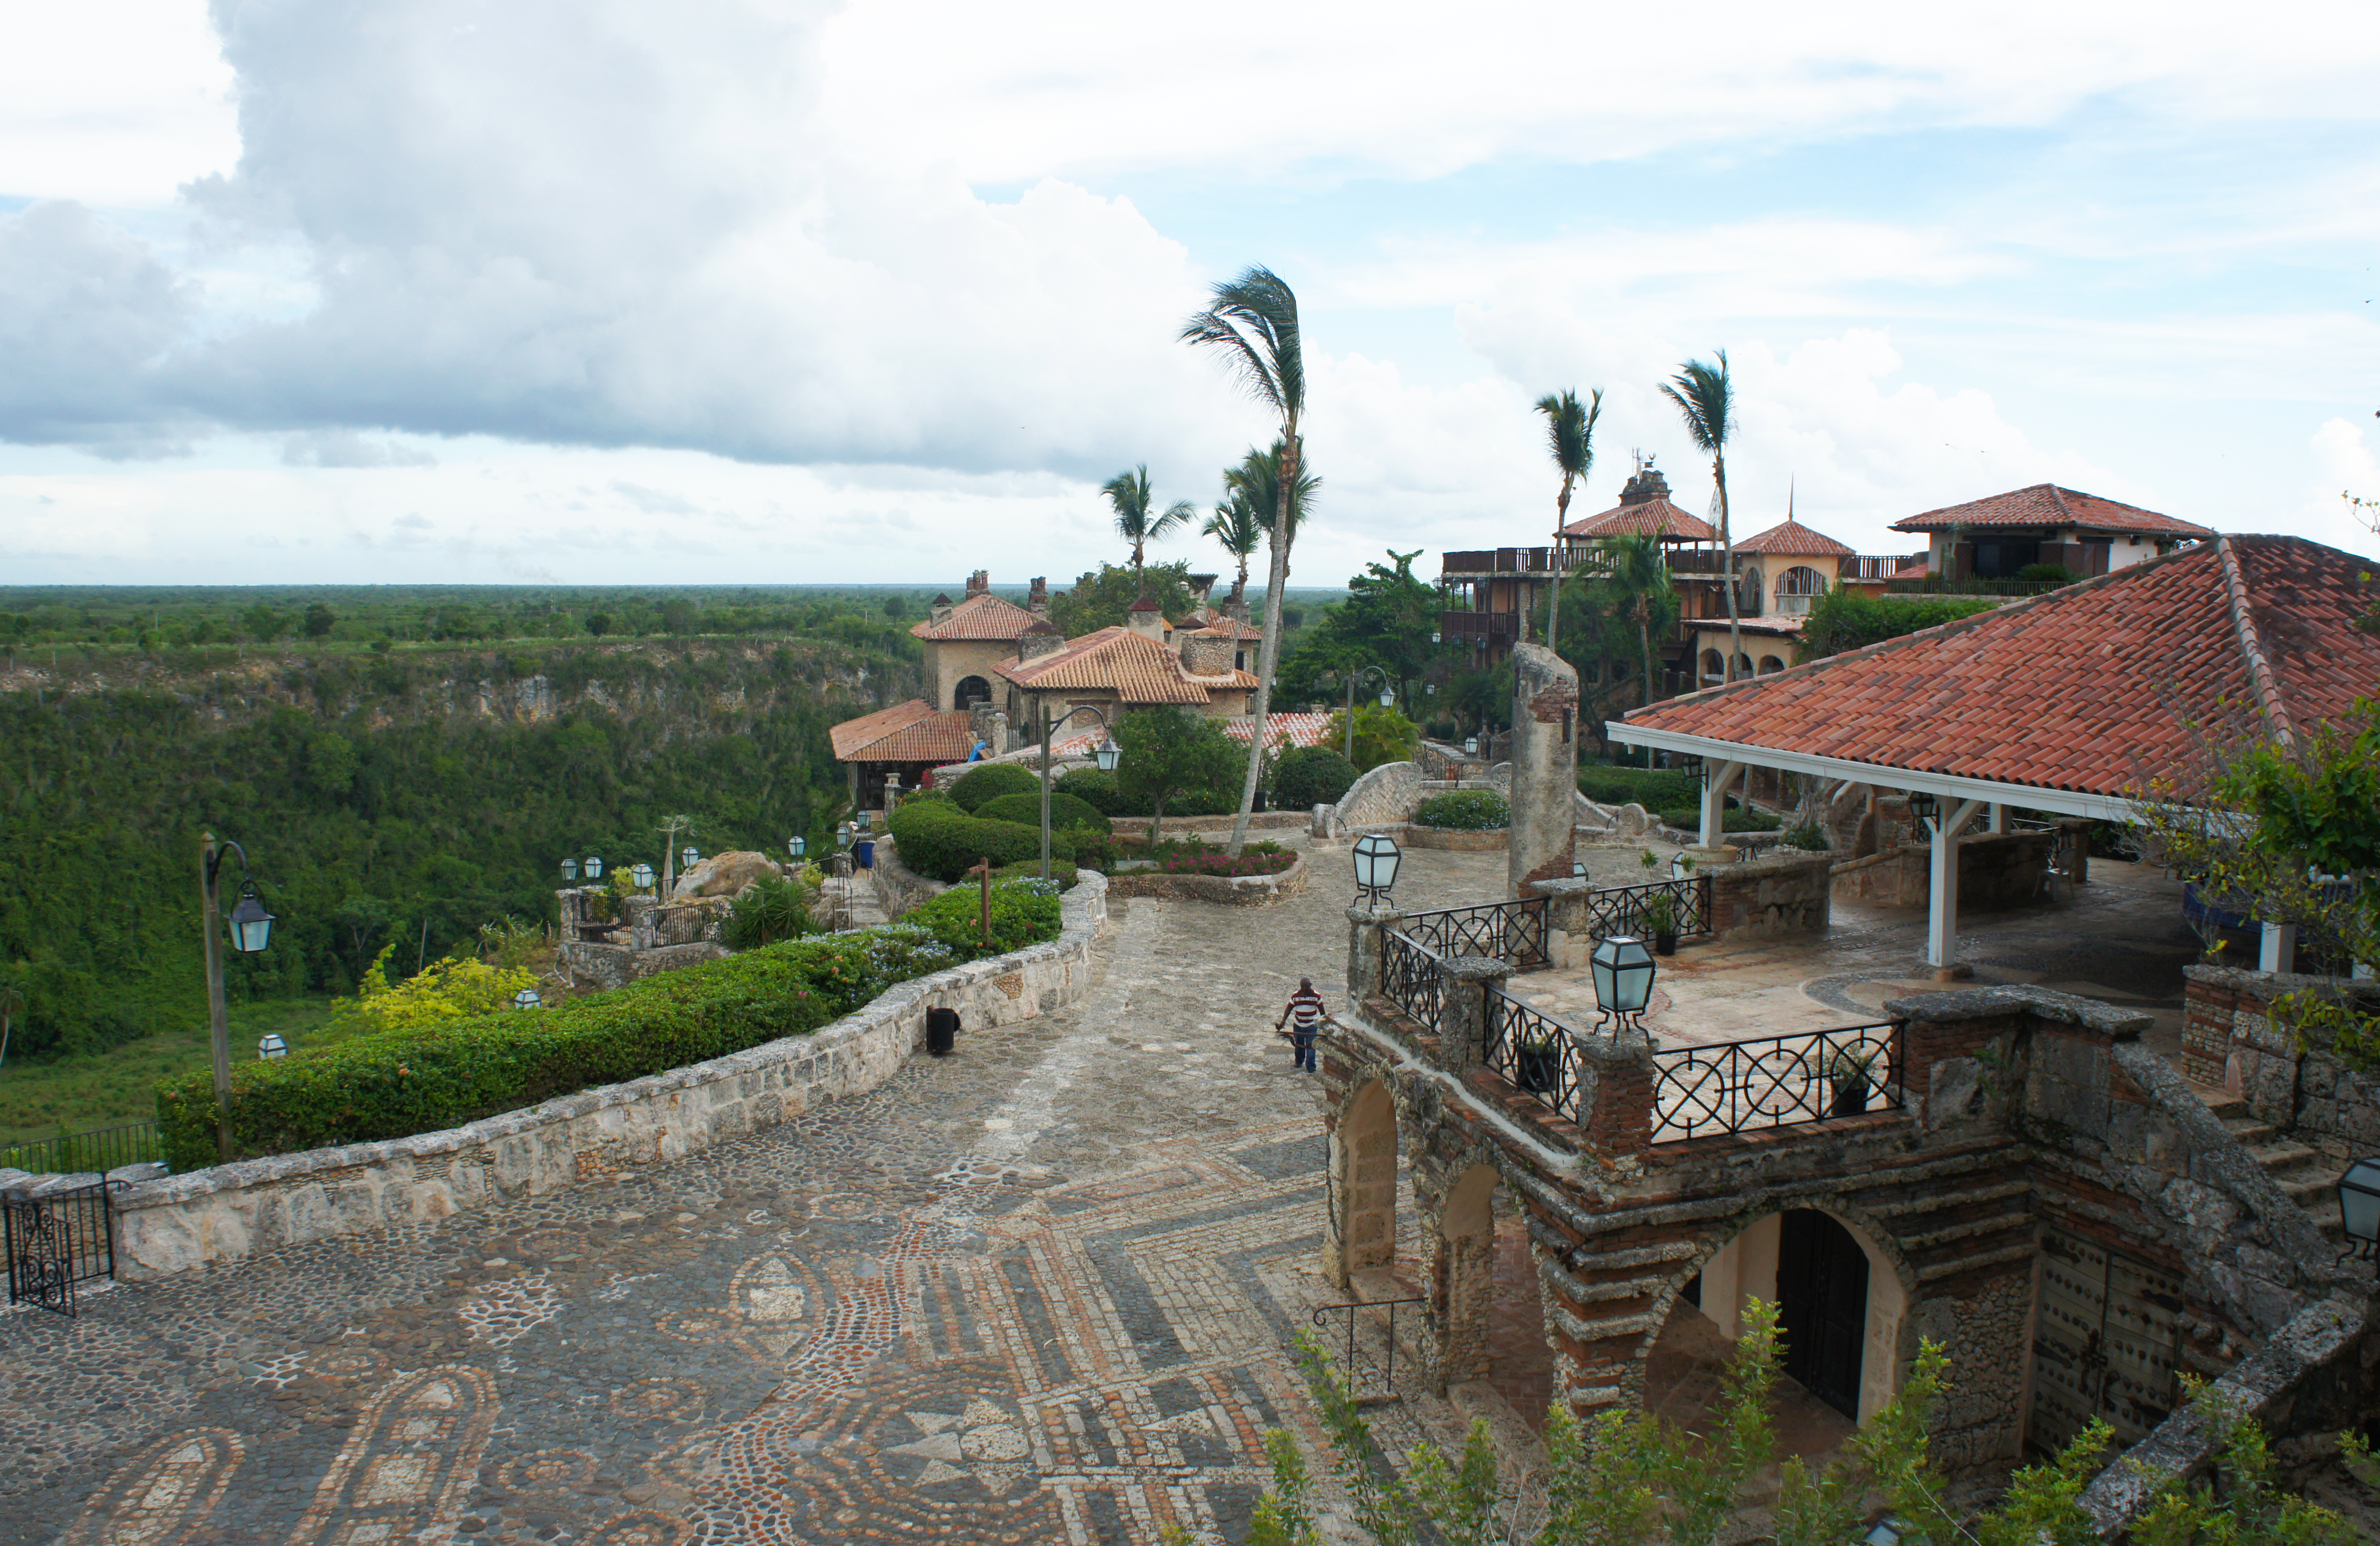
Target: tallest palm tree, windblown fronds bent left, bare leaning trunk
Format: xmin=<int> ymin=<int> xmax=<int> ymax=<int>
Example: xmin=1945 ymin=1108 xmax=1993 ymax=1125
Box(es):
xmin=1180 ymin=266 xmax=1307 ymax=856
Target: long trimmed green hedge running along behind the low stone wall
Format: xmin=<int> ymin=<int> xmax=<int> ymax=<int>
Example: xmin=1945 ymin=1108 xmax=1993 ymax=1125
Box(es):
xmin=157 ymin=892 xmax=1059 ymax=1170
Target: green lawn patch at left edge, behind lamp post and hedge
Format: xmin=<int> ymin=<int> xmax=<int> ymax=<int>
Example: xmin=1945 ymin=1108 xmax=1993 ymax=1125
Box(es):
xmin=0 ymin=999 xmax=343 ymax=1144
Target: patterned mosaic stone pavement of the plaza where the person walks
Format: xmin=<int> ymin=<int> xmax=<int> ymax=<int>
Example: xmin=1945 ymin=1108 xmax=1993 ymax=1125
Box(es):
xmin=0 ymin=854 xmax=1504 ymax=1546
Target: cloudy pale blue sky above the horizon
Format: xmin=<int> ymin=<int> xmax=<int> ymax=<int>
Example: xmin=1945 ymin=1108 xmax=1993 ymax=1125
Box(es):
xmin=0 ymin=0 xmax=2380 ymax=583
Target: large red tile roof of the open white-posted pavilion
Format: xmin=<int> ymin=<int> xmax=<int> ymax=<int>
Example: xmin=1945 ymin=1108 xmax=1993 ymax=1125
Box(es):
xmin=1621 ymin=538 xmax=2380 ymax=797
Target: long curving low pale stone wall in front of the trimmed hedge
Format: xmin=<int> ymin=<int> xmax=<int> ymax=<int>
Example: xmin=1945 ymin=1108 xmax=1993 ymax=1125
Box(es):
xmin=117 ymin=873 xmax=1107 ymax=1280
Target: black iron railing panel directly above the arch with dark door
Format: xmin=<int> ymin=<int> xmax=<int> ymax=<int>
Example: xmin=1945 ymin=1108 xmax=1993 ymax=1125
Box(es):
xmin=1652 ymin=1021 xmax=1904 ymax=1144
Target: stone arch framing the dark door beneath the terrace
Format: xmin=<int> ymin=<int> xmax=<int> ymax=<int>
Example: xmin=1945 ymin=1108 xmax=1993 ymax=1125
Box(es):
xmin=1637 ymin=1196 xmax=1918 ymax=1423
